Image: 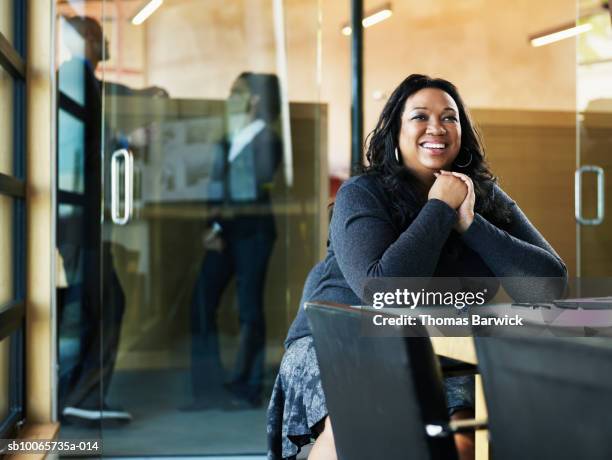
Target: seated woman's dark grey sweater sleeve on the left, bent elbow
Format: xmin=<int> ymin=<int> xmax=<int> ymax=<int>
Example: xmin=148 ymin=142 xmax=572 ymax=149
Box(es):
xmin=330 ymin=183 xmax=457 ymax=299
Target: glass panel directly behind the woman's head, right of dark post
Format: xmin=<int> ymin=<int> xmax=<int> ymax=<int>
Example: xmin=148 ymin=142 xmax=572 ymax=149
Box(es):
xmin=358 ymin=0 xmax=577 ymax=274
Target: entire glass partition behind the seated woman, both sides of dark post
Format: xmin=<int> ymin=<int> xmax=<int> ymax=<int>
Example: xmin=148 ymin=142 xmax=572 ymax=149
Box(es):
xmin=51 ymin=0 xmax=612 ymax=456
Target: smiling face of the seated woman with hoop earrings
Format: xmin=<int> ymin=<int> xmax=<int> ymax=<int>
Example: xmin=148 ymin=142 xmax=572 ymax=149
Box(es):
xmin=399 ymin=88 xmax=461 ymax=182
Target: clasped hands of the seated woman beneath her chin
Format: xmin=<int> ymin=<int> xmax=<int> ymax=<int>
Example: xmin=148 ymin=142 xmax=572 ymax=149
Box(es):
xmin=427 ymin=170 xmax=476 ymax=233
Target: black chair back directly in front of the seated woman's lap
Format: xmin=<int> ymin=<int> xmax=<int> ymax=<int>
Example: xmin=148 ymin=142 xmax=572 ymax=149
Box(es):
xmin=306 ymin=304 xmax=457 ymax=460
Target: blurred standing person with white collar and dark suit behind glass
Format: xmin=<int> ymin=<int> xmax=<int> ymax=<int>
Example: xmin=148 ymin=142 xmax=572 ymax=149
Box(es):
xmin=184 ymin=72 xmax=283 ymax=410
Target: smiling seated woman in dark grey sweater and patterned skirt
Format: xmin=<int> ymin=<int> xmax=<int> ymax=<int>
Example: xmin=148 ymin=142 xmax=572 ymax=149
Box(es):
xmin=268 ymin=75 xmax=567 ymax=459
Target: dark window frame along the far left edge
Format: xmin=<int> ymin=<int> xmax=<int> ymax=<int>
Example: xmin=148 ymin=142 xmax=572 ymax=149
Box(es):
xmin=0 ymin=0 xmax=27 ymax=439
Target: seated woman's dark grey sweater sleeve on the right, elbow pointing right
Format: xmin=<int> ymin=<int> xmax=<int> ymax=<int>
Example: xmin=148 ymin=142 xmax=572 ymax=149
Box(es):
xmin=462 ymin=186 xmax=567 ymax=300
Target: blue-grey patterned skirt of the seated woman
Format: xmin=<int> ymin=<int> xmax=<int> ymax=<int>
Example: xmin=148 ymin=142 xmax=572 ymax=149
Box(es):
xmin=267 ymin=336 xmax=474 ymax=460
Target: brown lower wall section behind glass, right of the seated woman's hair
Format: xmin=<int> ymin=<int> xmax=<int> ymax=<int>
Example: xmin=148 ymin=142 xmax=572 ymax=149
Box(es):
xmin=473 ymin=110 xmax=576 ymax=276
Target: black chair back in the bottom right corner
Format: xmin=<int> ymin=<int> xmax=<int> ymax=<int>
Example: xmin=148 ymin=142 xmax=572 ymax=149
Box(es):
xmin=475 ymin=337 xmax=612 ymax=460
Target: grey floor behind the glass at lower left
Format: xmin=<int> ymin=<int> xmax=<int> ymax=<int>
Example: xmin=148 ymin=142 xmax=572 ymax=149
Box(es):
xmin=60 ymin=370 xmax=269 ymax=460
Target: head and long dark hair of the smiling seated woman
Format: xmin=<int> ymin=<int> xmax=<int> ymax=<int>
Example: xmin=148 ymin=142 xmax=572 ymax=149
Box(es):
xmin=363 ymin=74 xmax=510 ymax=234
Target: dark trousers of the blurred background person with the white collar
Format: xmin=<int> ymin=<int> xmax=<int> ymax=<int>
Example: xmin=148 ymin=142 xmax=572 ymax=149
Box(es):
xmin=191 ymin=226 xmax=275 ymax=408
